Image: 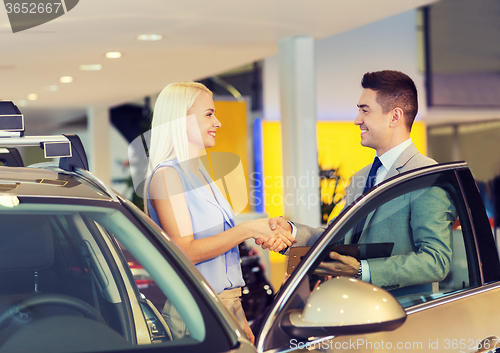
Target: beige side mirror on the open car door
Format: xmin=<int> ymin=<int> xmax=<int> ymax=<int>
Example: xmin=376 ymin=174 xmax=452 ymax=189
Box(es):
xmin=281 ymin=277 xmax=406 ymax=338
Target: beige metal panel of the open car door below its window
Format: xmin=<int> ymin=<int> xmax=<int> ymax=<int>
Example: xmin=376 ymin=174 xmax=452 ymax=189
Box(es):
xmin=330 ymin=283 xmax=500 ymax=352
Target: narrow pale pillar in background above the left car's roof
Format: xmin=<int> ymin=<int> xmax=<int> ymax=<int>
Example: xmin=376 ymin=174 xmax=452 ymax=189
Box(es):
xmin=87 ymin=106 xmax=111 ymax=186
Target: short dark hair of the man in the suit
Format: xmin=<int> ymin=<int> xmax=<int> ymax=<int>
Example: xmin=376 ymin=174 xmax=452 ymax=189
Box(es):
xmin=361 ymin=70 xmax=418 ymax=131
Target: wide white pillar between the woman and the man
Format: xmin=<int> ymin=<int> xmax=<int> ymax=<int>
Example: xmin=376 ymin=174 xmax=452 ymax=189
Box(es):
xmin=278 ymin=37 xmax=321 ymax=227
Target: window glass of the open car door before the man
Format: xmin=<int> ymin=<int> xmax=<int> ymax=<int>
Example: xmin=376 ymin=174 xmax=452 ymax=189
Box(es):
xmin=311 ymin=172 xmax=480 ymax=307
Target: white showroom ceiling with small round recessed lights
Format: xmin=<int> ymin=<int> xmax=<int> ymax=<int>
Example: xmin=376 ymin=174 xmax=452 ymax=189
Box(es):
xmin=0 ymin=0 xmax=435 ymax=133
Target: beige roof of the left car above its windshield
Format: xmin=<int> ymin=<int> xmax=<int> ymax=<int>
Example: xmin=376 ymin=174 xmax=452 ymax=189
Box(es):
xmin=0 ymin=167 xmax=112 ymax=201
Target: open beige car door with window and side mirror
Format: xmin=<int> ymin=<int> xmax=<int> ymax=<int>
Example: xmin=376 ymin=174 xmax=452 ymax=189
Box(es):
xmin=256 ymin=163 xmax=500 ymax=352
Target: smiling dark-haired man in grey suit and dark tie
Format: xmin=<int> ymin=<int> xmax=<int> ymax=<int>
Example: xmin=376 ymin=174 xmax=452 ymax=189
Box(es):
xmin=263 ymin=70 xmax=455 ymax=293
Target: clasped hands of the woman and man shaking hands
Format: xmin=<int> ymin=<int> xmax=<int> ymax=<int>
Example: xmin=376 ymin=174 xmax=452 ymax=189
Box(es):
xmin=241 ymin=217 xmax=297 ymax=252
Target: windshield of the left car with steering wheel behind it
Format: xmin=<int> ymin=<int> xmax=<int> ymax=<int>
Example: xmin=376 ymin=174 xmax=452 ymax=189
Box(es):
xmin=0 ymin=200 xmax=230 ymax=352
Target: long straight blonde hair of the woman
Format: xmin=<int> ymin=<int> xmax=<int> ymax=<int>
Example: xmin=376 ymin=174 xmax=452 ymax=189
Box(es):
xmin=144 ymin=82 xmax=212 ymax=214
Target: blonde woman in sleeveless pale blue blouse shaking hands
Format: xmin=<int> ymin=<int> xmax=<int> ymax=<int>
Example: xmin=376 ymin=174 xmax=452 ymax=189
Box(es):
xmin=145 ymin=82 xmax=294 ymax=342
